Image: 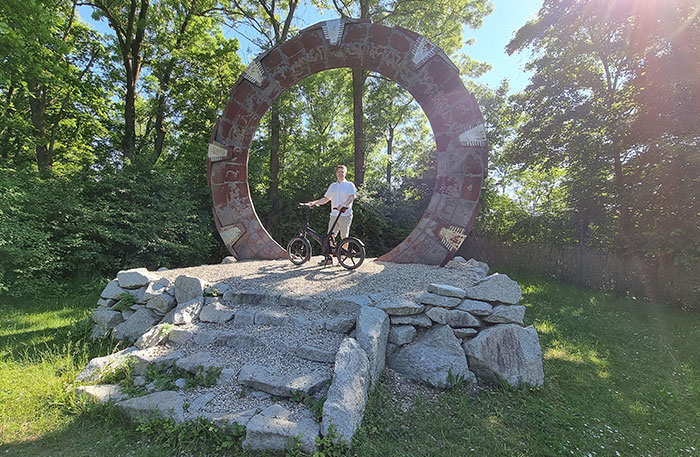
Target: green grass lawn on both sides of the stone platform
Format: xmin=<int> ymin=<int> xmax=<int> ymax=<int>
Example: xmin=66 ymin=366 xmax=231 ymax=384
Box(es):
xmin=0 ymin=274 xmax=700 ymax=457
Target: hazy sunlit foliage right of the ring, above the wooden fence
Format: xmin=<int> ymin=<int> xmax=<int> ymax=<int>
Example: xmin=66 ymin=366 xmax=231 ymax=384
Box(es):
xmin=504 ymin=0 xmax=700 ymax=268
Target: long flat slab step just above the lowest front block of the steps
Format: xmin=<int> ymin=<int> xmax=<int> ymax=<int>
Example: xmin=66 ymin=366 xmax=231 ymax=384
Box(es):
xmin=238 ymin=365 xmax=331 ymax=397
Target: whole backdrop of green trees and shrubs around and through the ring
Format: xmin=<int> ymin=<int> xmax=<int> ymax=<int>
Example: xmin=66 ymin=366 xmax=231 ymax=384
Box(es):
xmin=0 ymin=0 xmax=700 ymax=302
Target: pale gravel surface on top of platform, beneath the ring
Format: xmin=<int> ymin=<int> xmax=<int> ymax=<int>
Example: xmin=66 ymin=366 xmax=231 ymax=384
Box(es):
xmin=159 ymin=256 xmax=484 ymax=298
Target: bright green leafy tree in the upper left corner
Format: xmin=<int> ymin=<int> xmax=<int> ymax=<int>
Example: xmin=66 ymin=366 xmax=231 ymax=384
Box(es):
xmin=0 ymin=0 xmax=110 ymax=177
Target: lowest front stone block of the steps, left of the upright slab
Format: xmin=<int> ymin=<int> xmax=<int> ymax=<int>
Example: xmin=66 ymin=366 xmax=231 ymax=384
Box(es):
xmin=243 ymin=405 xmax=319 ymax=454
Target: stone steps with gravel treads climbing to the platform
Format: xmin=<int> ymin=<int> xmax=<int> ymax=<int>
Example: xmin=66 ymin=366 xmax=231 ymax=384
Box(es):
xmin=78 ymin=285 xmax=368 ymax=452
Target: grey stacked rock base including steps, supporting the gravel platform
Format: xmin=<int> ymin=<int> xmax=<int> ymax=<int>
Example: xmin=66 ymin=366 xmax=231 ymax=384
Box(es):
xmin=78 ymin=260 xmax=544 ymax=452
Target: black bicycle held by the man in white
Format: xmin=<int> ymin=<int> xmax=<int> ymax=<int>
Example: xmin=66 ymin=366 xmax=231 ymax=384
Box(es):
xmin=287 ymin=203 xmax=365 ymax=270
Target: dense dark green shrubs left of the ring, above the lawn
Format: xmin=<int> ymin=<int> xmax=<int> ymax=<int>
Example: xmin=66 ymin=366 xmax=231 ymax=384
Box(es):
xmin=0 ymin=168 xmax=220 ymax=295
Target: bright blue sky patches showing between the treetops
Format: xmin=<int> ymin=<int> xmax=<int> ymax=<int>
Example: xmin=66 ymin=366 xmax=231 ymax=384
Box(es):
xmin=79 ymin=0 xmax=542 ymax=93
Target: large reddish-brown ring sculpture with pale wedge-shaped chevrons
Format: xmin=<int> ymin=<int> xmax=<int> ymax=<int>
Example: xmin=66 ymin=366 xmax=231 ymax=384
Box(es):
xmin=207 ymin=19 xmax=488 ymax=265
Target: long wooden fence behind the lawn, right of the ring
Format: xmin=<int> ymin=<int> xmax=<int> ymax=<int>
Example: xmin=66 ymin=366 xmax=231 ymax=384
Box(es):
xmin=457 ymin=235 xmax=700 ymax=310
